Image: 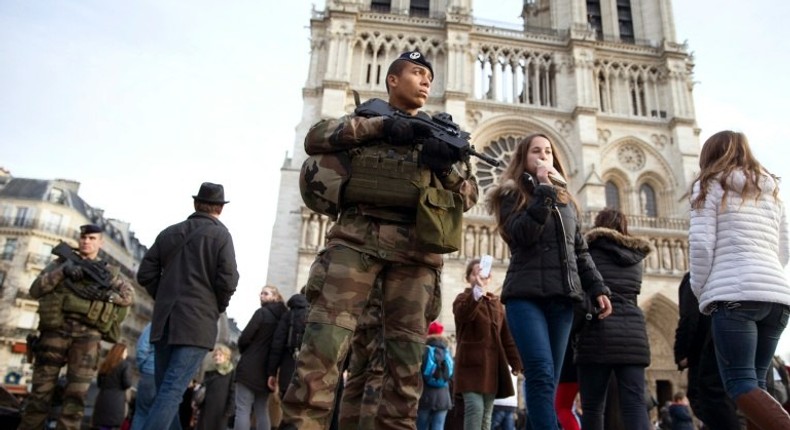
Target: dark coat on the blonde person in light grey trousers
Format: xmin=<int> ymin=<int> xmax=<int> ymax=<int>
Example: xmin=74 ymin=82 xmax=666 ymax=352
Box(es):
xmin=236 ymin=302 xmax=288 ymax=393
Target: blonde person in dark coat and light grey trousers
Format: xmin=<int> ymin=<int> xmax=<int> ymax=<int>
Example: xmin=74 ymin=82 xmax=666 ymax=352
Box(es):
xmin=234 ymin=285 xmax=288 ymax=430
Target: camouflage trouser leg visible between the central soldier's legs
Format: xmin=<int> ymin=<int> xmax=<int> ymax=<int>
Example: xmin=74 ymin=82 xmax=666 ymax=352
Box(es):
xmin=339 ymin=278 xmax=385 ymax=430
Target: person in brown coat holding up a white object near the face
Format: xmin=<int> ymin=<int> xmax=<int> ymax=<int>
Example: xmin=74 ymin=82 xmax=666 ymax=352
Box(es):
xmin=453 ymin=259 xmax=524 ymax=430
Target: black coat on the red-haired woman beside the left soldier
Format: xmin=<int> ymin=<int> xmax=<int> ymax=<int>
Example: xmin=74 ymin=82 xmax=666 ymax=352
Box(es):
xmin=91 ymin=360 xmax=132 ymax=427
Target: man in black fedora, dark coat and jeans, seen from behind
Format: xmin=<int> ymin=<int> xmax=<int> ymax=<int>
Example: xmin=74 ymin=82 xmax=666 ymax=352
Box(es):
xmin=137 ymin=182 xmax=239 ymax=430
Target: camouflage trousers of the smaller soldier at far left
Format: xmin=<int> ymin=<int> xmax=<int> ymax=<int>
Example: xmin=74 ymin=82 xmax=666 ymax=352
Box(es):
xmin=18 ymin=319 xmax=101 ymax=430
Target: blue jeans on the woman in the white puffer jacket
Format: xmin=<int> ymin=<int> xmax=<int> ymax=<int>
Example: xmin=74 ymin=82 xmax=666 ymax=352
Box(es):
xmin=711 ymin=301 xmax=790 ymax=400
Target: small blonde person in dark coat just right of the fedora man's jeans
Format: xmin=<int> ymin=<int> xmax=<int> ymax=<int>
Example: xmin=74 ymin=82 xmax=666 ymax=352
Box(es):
xmin=196 ymin=345 xmax=235 ymax=430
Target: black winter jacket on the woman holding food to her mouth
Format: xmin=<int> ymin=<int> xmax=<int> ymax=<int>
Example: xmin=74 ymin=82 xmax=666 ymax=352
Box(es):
xmin=499 ymin=181 xmax=608 ymax=303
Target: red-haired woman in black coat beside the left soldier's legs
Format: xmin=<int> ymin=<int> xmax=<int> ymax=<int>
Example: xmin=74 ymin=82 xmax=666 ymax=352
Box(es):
xmin=92 ymin=343 xmax=132 ymax=430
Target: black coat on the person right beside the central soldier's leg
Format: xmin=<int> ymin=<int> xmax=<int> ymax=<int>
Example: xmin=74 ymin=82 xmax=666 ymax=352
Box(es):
xmin=268 ymin=293 xmax=309 ymax=394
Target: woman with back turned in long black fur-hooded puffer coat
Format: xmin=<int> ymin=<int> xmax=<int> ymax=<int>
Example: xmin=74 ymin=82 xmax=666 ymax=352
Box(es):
xmin=575 ymin=209 xmax=651 ymax=430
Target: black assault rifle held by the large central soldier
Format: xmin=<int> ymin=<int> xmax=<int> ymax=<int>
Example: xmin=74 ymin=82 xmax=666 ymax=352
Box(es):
xmin=354 ymin=99 xmax=499 ymax=166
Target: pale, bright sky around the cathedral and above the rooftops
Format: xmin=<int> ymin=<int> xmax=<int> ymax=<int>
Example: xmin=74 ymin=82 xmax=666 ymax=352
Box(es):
xmin=0 ymin=0 xmax=790 ymax=356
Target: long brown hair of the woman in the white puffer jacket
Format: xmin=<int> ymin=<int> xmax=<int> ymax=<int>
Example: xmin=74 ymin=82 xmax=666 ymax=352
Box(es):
xmin=691 ymin=130 xmax=779 ymax=209
